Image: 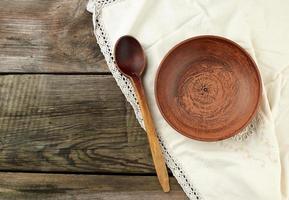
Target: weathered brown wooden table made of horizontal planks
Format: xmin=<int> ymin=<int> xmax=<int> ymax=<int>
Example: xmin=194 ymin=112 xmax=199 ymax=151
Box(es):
xmin=0 ymin=0 xmax=186 ymax=200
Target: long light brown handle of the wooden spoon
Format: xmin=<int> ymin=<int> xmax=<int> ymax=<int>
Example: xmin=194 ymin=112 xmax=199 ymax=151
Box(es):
xmin=131 ymin=77 xmax=170 ymax=192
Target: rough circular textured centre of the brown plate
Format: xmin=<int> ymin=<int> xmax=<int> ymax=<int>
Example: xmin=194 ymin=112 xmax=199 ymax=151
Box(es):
xmin=176 ymin=57 xmax=238 ymax=128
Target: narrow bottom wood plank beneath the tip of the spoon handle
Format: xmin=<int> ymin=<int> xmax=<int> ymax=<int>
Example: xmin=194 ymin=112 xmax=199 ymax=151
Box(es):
xmin=0 ymin=173 xmax=187 ymax=200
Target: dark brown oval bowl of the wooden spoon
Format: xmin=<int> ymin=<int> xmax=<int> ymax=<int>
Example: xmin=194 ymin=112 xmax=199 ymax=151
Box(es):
xmin=115 ymin=35 xmax=146 ymax=77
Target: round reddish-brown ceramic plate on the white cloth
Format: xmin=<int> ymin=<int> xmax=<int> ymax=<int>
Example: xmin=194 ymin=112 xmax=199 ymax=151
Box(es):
xmin=155 ymin=36 xmax=261 ymax=141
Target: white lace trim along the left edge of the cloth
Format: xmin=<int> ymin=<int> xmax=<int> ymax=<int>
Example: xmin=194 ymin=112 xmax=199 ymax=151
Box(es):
xmin=93 ymin=0 xmax=203 ymax=200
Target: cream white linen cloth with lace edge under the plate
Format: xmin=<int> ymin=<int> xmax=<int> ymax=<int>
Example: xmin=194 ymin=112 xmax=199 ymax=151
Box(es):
xmin=87 ymin=0 xmax=289 ymax=200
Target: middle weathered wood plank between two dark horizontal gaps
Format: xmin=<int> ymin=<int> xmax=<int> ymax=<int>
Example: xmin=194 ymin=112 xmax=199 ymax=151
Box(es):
xmin=0 ymin=75 xmax=155 ymax=173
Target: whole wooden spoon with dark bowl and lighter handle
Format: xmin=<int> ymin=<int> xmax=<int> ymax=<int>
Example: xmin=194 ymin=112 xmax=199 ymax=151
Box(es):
xmin=114 ymin=36 xmax=170 ymax=192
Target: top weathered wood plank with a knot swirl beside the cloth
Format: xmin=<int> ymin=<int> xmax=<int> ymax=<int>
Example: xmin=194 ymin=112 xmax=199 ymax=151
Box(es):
xmin=0 ymin=0 xmax=108 ymax=73
